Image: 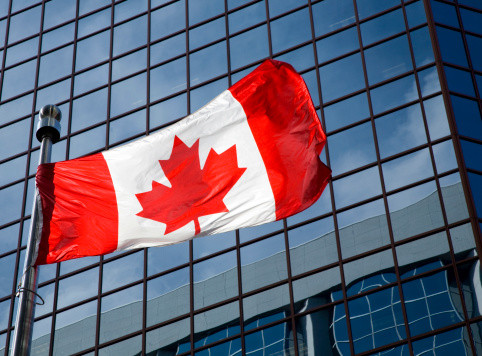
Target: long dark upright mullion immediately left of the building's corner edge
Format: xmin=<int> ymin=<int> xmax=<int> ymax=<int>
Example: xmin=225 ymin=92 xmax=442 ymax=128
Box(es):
xmin=402 ymin=5 xmax=476 ymax=356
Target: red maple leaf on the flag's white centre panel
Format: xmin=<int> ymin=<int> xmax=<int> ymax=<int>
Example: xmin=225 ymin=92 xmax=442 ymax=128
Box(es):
xmin=136 ymin=136 xmax=246 ymax=235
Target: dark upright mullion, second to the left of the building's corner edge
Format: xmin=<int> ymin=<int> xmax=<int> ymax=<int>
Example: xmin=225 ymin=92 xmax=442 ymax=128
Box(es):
xmin=353 ymin=0 xmax=415 ymax=353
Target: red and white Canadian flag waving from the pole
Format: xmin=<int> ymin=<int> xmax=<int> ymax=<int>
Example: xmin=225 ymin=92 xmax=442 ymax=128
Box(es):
xmin=36 ymin=60 xmax=331 ymax=264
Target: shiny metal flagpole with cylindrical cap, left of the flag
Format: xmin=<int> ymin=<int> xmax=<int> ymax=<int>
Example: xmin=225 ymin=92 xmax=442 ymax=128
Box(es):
xmin=12 ymin=105 xmax=62 ymax=356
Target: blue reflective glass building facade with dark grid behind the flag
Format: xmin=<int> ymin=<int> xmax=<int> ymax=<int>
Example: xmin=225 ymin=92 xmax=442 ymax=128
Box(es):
xmin=0 ymin=0 xmax=482 ymax=356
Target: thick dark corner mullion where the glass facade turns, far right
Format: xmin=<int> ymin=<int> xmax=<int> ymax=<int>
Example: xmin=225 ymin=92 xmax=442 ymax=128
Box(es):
xmin=423 ymin=0 xmax=482 ymax=256
